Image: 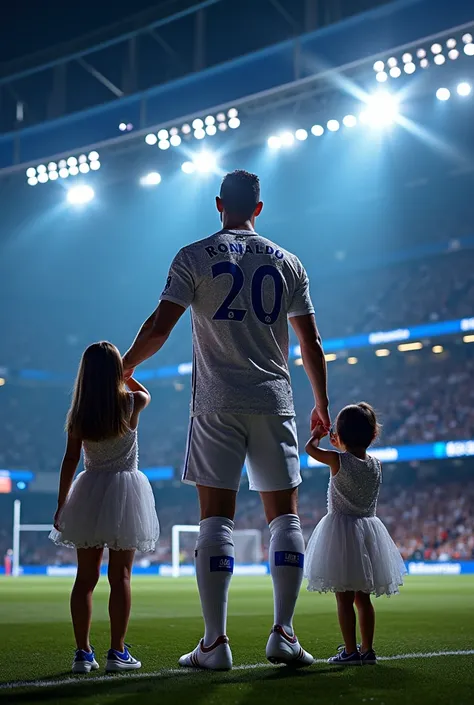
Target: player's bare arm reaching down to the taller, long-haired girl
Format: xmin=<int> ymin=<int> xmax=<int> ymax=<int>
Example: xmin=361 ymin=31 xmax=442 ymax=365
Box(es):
xmin=123 ymin=301 xmax=186 ymax=377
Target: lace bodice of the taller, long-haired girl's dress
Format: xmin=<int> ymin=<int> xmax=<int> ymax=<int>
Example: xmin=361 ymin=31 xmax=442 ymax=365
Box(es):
xmin=82 ymin=393 xmax=138 ymax=472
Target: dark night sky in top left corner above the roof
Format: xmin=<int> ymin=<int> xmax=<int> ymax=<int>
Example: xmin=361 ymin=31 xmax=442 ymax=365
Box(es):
xmin=0 ymin=0 xmax=161 ymax=64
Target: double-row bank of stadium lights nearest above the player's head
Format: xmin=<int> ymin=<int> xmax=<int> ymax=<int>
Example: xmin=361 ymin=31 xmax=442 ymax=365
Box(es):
xmin=145 ymin=108 xmax=240 ymax=150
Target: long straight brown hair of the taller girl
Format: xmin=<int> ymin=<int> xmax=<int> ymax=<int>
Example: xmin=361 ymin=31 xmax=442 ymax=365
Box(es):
xmin=66 ymin=341 xmax=129 ymax=441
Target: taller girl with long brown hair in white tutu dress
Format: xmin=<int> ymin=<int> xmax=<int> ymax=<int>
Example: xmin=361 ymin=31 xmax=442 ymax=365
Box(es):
xmin=49 ymin=342 xmax=159 ymax=673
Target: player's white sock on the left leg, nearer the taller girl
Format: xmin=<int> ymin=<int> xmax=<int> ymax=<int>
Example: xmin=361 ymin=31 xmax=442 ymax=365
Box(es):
xmin=195 ymin=517 xmax=234 ymax=646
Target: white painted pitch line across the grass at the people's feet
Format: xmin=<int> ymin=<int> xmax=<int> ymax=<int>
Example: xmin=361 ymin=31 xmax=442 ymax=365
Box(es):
xmin=0 ymin=649 xmax=474 ymax=690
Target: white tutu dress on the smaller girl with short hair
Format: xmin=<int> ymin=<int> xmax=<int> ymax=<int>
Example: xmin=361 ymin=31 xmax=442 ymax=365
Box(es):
xmin=305 ymin=453 xmax=406 ymax=597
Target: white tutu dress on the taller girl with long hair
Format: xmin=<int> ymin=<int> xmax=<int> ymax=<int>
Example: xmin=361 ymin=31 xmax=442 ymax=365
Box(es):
xmin=49 ymin=394 xmax=160 ymax=551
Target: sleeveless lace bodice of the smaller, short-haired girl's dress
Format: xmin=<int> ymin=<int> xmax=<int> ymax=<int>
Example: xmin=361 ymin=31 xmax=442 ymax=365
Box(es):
xmin=328 ymin=453 xmax=382 ymax=517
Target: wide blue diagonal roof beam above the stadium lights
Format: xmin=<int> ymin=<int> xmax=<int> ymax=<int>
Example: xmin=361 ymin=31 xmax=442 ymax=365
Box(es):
xmin=0 ymin=0 xmax=473 ymax=173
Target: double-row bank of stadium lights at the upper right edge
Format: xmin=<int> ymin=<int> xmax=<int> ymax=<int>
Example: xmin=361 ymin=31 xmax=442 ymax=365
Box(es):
xmin=374 ymin=33 xmax=474 ymax=83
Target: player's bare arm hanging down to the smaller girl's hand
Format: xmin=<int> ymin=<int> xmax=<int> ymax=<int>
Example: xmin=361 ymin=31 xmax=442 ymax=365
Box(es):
xmin=290 ymin=313 xmax=331 ymax=431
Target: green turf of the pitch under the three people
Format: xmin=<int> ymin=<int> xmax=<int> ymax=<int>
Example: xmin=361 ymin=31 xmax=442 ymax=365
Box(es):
xmin=0 ymin=576 xmax=474 ymax=705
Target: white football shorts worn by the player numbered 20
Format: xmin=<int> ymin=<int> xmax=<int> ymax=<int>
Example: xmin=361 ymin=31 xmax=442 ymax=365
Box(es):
xmin=182 ymin=412 xmax=301 ymax=492
